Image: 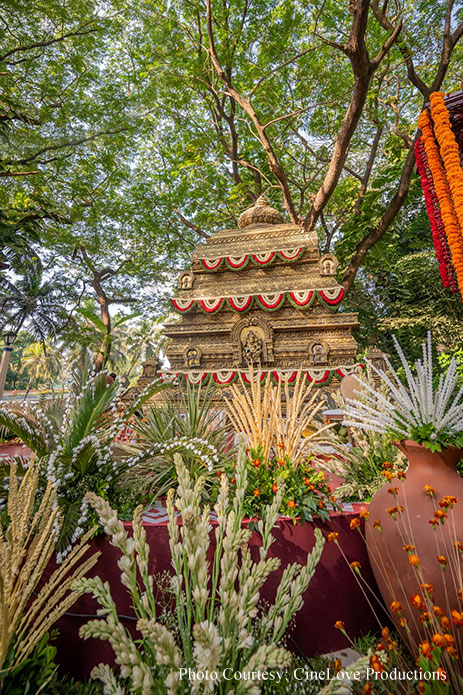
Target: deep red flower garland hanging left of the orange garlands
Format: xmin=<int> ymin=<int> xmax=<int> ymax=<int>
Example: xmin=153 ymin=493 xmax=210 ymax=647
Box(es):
xmin=415 ymin=138 xmax=458 ymax=292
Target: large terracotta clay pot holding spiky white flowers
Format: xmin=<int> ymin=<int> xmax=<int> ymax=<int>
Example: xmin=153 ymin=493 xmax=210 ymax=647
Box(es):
xmin=365 ymin=440 xmax=463 ymax=644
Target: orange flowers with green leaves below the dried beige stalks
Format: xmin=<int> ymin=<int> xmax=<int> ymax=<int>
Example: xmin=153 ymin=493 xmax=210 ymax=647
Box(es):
xmin=234 ymin=447 xmax=341 ymax=523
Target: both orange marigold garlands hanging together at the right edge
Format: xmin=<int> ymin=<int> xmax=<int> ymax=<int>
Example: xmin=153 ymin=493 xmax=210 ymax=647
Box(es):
xmin=418 ymin=92 xmax=463 ymax=297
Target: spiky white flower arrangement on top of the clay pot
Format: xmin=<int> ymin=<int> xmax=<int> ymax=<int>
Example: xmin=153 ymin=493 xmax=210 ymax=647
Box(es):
xmin=344 ymin=333 xmax=463 ymax=451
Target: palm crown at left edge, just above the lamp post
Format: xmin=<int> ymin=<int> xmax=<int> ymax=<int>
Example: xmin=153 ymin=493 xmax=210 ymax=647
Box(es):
xmin=0 ymin=260 xmax=68 ymax=343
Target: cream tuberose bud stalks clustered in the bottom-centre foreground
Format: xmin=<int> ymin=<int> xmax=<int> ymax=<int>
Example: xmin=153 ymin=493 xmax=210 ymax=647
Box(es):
xmin=75 ymin=456 xmax=324 ymax=695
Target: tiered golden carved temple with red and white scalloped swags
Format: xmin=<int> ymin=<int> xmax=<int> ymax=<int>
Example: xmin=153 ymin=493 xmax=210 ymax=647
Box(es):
xmin=139 ymin=198 xmax=358 ymax=388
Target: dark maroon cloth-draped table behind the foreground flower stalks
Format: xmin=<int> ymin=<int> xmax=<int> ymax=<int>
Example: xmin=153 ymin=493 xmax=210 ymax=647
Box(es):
xmin=50 ymin=505 xmax=378 ymax=678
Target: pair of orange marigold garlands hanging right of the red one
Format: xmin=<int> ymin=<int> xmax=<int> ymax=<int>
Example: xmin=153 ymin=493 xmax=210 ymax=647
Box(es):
xmin=418 ymin=106 xmax=463 ymax=297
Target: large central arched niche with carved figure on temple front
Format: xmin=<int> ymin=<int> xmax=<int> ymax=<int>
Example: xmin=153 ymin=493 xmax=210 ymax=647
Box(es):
xmin=231 ymin=317 xmax=273 ymax=366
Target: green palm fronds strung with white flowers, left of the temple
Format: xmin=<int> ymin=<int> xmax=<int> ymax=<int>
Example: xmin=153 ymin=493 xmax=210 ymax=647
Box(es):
xmin=0 ymin=358 xmax=166 ymax=552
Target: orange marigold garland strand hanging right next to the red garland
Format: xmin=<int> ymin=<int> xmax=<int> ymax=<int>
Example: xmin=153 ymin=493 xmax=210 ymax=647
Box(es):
xmin=418 ymin=110 xmax=463 ymax=297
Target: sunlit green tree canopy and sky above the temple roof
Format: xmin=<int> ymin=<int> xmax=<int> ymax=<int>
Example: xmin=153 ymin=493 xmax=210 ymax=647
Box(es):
xmin=0 ymin=0 xmax=461 ymax=333
